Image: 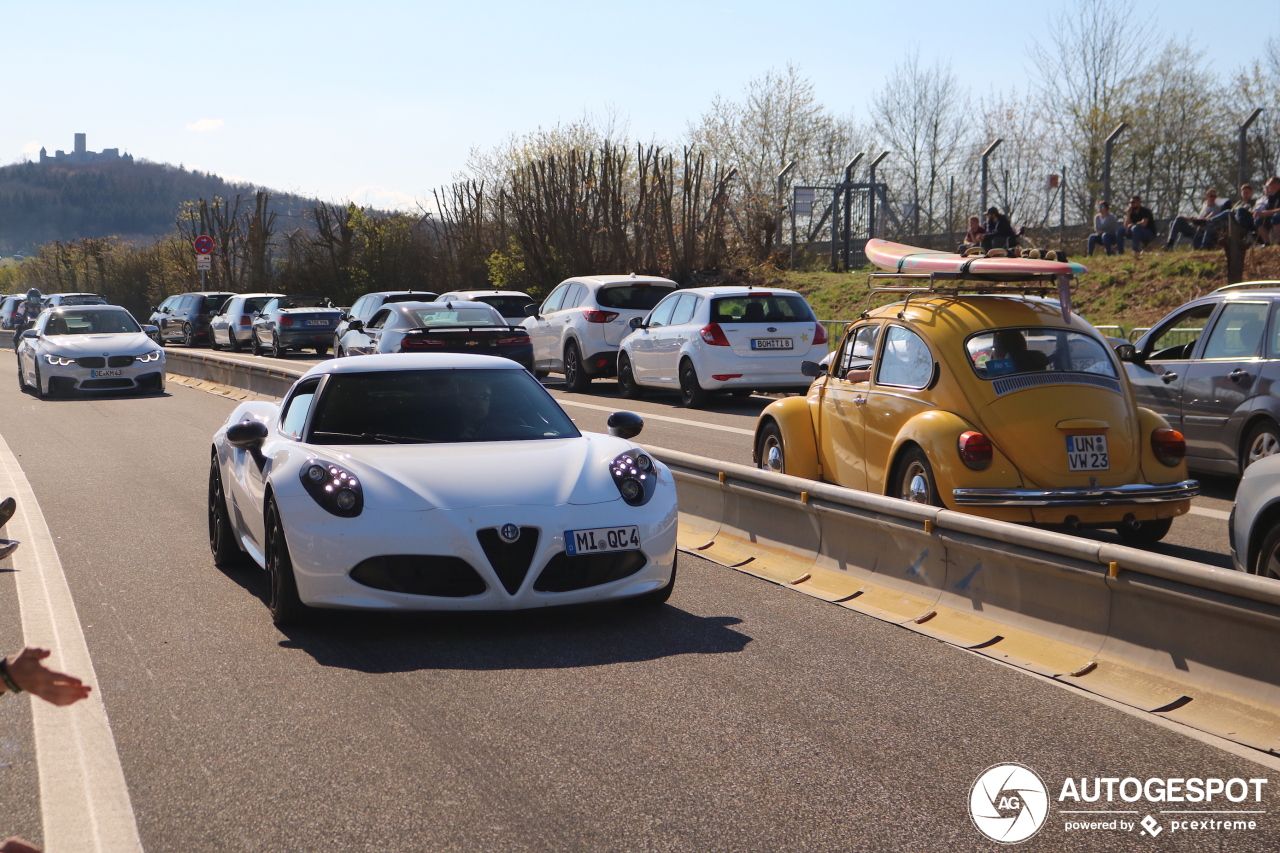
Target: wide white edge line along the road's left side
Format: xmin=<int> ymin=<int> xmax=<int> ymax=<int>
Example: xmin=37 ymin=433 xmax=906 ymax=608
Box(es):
xmin=0 ymin=437 xmax=142 ymax=853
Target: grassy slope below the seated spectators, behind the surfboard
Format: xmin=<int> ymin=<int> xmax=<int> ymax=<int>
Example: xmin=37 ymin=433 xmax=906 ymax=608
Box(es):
xmin=765 ymin=246 xmax=1280 ymax=332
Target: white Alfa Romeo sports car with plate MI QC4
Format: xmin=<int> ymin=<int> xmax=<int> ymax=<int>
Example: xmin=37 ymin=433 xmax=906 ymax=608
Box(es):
xmin=209 ymin=353 xmax=676 ymax=624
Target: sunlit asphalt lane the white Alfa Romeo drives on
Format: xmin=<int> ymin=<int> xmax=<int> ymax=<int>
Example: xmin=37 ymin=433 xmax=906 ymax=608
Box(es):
xmin=0 ymin=353 xmax=1280 ymax=853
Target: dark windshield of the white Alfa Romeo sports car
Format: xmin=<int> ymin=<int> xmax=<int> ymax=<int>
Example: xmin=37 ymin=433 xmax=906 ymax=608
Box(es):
xmin=310 ymin=368 xmax=580 ymax=444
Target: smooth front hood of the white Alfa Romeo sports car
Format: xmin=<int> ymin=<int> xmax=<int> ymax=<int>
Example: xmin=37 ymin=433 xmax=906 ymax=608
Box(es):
xmin=342 ymin=434 xmax=634 ymax=510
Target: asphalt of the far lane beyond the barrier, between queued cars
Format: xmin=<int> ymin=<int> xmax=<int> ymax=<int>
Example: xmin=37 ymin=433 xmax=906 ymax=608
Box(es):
xmin=212 ymin=352 xmax=1235 ymax=569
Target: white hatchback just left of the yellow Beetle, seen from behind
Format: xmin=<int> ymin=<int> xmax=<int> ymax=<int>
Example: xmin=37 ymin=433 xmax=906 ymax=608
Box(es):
xmin=618 ymin=287 xmax=827 ymax=409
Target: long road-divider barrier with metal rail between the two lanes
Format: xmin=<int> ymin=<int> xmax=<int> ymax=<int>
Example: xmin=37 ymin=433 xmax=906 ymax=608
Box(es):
xmin=140 ymin=351 xmax=1280 ymax=754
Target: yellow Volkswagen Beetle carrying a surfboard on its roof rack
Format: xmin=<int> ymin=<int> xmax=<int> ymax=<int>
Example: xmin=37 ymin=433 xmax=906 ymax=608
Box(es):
xmin=754 ymin=285 xmax=1198 ymax=544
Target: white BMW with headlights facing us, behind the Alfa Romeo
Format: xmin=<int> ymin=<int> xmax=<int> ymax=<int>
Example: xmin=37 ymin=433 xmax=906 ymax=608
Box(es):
xmin=18 ymin=305 xmax=165 ymax=397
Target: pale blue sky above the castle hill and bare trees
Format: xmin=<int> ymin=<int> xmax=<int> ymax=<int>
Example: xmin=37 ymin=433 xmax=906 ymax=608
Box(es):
xmin=0 ymin=0 xmax=1280 ymax=206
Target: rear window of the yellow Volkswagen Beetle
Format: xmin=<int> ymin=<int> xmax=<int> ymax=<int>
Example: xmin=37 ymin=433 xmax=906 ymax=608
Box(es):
xmin=965 ymin=328 xmax=1116 ymax=379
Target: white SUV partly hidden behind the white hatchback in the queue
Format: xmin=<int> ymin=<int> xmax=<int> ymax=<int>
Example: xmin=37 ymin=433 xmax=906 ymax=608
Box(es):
xmin=522 ymin=273 xmax=677 ymax=391
